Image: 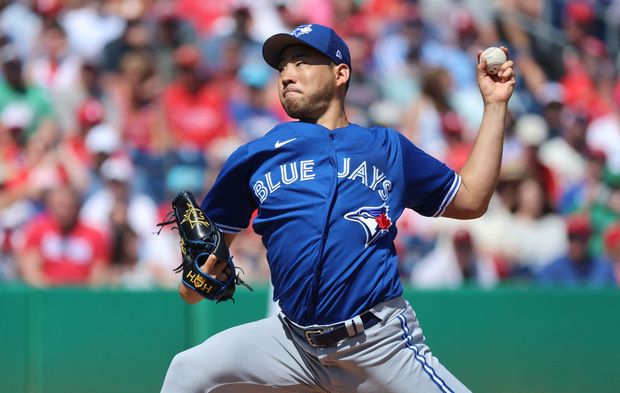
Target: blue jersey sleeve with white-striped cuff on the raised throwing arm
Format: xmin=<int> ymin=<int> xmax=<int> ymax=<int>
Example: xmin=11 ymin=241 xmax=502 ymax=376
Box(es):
xmin=398 ymin=133 xmax=461 ymax=217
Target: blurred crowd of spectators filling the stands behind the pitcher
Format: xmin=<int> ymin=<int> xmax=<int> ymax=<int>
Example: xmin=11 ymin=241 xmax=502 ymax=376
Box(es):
xmin=0 ymin=0 xmax=620 ymax=288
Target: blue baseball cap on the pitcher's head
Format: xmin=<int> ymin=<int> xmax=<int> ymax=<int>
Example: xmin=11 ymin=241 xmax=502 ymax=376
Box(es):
xmin=263 ymin=23 xmax=351 ymax=69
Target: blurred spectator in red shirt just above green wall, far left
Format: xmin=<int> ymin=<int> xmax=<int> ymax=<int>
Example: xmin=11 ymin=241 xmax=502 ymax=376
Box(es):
xmin=19 ymin=185 xmax=109 ymax=287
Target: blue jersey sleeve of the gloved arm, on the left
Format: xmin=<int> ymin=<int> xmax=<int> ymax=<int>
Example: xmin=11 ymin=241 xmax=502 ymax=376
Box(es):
xmin=201 ymin=145 xmax=256 ymax=234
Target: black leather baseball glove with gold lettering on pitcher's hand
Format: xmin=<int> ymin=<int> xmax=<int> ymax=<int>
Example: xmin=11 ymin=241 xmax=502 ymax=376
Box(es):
xmin=157 ymin=191 xmax=252 ymax=302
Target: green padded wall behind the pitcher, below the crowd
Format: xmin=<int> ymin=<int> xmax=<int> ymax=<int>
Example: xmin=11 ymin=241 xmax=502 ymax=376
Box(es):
xmin=0 ymin=285 xmax=620 ymax=393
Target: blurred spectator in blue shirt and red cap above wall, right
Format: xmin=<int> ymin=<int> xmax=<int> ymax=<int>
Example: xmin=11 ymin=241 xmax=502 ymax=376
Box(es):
xmin=537 ymin=216 xmax=615 ymax=286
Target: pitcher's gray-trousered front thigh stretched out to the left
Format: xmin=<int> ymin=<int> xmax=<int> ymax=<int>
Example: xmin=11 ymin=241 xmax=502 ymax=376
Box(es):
xmin=162 ymin=316 xmax=324 ymax=393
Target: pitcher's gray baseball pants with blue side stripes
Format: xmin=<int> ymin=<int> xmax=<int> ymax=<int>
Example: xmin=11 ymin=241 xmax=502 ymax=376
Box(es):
xmin=161 ymin=297 xmax=469 ymax=393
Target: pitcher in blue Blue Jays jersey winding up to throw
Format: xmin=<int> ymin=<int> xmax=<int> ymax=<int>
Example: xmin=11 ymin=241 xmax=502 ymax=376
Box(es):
xmin=162 ymin=24 xmax=515 ymax=393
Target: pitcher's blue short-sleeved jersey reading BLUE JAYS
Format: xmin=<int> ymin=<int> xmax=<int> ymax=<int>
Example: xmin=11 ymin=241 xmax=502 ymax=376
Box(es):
xmin=202 ymin=122 xmax=461 ymax=325
